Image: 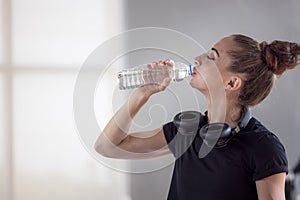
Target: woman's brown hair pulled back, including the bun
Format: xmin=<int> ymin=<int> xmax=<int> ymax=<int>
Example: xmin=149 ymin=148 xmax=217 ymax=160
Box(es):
xmin=228 ymin=35 xmax=300 ymax=106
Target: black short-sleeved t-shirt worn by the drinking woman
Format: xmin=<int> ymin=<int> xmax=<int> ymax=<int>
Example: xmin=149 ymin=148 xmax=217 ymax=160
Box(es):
xmin=163 ymin=118 xmax=288 ymax=200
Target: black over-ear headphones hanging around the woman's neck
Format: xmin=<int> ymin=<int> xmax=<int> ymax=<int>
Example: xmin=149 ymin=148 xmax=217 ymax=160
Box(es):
xmin=173 ymin=107 xmax=251 ymax=148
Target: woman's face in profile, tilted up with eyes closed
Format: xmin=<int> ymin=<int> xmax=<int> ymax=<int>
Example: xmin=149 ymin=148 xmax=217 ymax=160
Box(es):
xmin=190 ymin=37 xmax=234 ymax=94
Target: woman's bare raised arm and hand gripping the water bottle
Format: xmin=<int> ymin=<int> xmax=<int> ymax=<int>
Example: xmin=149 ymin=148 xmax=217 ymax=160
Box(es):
xmin=94 ymin=60 xmax=173 ymax=159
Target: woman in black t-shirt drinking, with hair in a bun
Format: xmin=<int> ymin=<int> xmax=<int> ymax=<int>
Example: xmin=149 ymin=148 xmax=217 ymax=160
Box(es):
xmin=95 ymin=35 xmax=300 ymax=200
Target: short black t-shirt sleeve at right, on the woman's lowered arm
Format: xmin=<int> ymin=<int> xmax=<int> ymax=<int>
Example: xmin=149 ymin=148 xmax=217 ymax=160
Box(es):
xmin=252 ymin=133 xmax=288 ymax=181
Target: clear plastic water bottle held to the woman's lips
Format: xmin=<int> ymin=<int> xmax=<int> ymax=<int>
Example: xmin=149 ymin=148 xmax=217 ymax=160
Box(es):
xmin=118 ymin=62 xmax=192 ymax=90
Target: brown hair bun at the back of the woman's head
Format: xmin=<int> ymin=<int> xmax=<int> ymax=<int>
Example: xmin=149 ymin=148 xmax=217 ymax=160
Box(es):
xmin=259 ymin=40 xmax=300 ymax=76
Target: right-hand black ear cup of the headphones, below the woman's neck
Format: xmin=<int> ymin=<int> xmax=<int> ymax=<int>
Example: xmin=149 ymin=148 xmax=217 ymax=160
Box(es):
xmin=199 ymin=123 xmax=231 ymax=146
